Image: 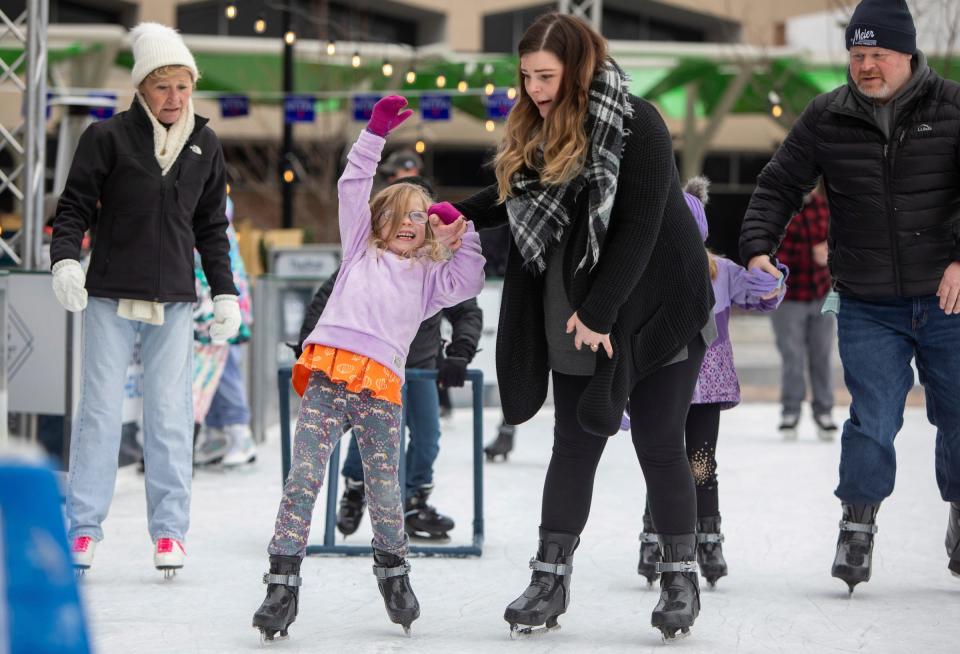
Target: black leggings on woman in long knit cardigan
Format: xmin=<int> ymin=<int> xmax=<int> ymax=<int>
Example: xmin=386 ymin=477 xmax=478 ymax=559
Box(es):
xmin=540 ymin=335 xmax=706 ymax=535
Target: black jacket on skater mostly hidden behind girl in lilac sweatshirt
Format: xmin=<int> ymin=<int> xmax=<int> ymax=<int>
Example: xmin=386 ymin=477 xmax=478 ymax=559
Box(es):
xmin=297 ymin=268 xmax=483 ymax=370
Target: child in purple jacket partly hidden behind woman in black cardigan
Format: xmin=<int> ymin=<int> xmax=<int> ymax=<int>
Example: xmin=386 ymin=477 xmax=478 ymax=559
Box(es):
xmin=637 ymin=177 xmax=789 ymax=586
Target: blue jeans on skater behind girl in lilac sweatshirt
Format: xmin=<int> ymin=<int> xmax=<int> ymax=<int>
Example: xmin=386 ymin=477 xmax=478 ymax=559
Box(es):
xmin=343 ymin=379 xmax=440 ymax=496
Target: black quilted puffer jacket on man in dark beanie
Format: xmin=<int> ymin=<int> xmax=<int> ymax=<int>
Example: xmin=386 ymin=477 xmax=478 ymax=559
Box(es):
xmin=740 ymin=71 xmax=960 ymax=298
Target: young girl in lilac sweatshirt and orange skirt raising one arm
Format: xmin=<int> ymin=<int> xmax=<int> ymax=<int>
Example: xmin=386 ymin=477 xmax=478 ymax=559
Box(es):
xmin=253 ymin=96 xmax=484 ymax=640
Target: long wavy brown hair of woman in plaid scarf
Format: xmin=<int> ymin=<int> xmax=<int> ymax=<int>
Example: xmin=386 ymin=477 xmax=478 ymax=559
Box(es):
xmin=494 ymin=12 xmax=607 ymax=202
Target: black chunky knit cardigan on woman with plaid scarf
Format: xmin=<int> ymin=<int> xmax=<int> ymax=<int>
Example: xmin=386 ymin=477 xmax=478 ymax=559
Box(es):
xmin=455 ymin=98 xmax=713 ymax=436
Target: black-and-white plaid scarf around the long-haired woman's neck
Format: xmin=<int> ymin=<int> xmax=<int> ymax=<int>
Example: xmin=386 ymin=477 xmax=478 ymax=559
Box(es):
xmin=507 ymin=59 xmax=633 ymax=274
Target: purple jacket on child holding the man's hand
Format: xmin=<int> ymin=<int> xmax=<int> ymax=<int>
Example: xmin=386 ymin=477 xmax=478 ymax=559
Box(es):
xmin=691 ymin=257 xmax=783 ymax=409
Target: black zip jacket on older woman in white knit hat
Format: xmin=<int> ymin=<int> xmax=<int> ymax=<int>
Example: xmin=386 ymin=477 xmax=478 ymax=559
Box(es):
xmin=50 ymin=99 xmax=237 ymax=302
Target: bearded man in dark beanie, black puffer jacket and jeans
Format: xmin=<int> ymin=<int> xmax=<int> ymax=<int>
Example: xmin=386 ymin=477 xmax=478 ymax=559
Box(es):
xmin=740 ymin=0 xmax=960 ymax=593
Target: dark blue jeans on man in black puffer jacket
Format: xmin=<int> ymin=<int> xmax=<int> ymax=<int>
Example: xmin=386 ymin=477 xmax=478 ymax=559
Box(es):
xmin=835 ymin=296 xmax=960 ymax=504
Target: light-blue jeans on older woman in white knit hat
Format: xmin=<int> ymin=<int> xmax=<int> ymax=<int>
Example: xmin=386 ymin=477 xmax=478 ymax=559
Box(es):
xmin=66 ymin=297 xmax=193 ymax=540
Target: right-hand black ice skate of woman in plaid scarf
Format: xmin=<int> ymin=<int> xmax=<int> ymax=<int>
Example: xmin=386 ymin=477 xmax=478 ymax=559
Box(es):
xmin=650 ymin=534 xmax=700 ymax=642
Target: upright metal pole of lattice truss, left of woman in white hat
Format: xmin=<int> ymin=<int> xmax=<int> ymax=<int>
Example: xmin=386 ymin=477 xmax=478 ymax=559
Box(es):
xmin=23 ymin=0 xmax=49 ymax=270
